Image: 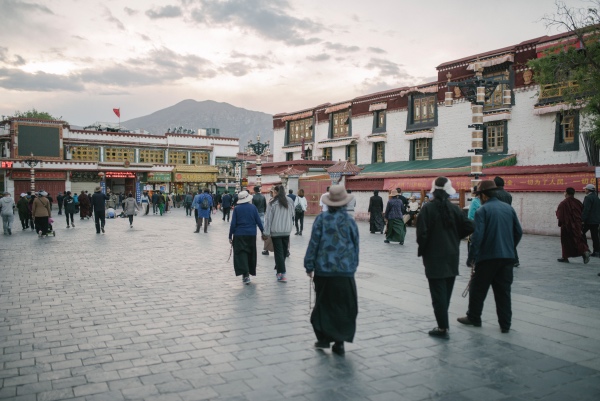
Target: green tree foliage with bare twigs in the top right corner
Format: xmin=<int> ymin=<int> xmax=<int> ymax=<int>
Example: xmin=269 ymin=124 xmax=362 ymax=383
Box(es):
xmin=528 ymin=0 xmax=600 ymax=144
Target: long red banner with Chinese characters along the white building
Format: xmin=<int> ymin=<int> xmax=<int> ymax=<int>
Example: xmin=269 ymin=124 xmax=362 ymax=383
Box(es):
xmin=383 ymin=171 xmax=596 ymax=192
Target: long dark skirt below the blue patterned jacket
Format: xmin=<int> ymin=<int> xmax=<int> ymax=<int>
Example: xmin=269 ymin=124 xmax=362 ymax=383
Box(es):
xmin=310 ymin=276 xmax=358 ymax=342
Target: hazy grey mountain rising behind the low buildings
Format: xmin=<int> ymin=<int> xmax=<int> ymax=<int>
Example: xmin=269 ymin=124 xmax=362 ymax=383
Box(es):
xmin=121 ymin=99 xmax=273 ymax=150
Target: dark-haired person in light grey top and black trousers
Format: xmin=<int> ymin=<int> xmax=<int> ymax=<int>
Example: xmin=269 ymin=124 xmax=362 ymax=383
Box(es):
xmin=264 ymin=185 xmax=294 ymax=283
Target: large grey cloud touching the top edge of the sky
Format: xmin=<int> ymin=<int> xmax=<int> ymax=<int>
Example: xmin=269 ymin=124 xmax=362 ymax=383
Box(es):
xmin=191 ymin=0 xmax=324 ymax=46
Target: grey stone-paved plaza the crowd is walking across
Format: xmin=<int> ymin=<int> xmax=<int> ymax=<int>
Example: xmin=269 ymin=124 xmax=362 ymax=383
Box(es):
xmin=0 ymin=209 xmax=600 ymax=401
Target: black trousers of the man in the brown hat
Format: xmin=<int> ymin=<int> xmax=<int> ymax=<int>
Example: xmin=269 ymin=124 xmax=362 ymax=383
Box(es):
xmin=467 ymin=259 xmax=515 ymax=329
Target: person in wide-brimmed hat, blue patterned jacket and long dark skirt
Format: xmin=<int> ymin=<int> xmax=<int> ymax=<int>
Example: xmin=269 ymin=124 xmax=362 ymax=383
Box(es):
xmin=304 ymin=185 xmax=359 ymax=355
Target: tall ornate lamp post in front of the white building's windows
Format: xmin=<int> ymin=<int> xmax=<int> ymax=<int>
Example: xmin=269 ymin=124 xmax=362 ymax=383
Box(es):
xmin=444 ymin=61 xmax=512 ymax=188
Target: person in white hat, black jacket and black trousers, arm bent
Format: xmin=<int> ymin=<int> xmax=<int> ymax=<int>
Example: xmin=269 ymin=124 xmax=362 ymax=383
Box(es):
xmin=417 ymin=177 xmax=475 ymax=338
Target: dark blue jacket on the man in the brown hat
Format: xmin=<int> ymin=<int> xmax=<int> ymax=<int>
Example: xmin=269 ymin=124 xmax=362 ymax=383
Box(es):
xmin=468 ymin=198 xmax=523 ymax=264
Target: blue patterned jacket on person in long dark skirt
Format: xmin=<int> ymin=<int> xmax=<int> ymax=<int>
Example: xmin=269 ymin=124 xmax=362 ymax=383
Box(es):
xmin=304 ymin=209 xmax=359 ymax=277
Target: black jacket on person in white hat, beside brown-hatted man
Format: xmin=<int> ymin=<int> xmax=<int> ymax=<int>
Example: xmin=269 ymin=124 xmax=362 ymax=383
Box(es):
xmin=417 ymin=198 xmax=475 ymax=278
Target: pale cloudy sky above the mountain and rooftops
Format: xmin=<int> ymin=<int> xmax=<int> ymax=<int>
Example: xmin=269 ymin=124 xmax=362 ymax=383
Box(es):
xmin=0 ymin=0 xmax=589 ymax=126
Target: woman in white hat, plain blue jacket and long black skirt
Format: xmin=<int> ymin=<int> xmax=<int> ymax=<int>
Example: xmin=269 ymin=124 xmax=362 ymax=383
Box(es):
xmin=229 ymin=191 xmax=264 ymax=284
